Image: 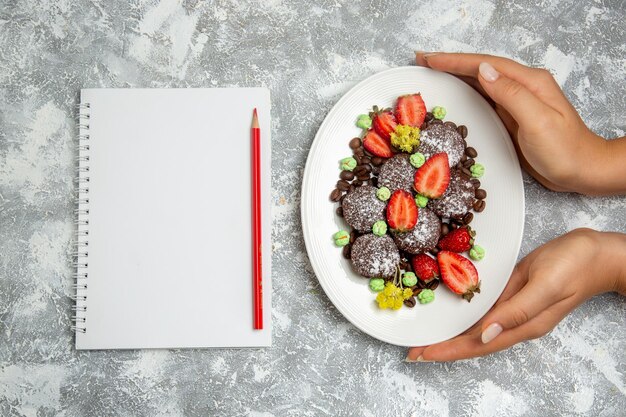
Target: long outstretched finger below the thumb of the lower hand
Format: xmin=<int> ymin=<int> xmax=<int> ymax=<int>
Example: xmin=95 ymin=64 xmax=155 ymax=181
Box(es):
xmin=420 ymin=299 xmax=575 ymax=362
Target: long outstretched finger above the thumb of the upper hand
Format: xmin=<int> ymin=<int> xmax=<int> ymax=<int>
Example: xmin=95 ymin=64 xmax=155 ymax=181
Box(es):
xmin=422 ymin=53 xmax=571 ymax=111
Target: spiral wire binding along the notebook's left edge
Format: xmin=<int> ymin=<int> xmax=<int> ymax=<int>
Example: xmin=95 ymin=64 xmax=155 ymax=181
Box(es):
xmin=71 ymin=103 xmax=91 ymax=333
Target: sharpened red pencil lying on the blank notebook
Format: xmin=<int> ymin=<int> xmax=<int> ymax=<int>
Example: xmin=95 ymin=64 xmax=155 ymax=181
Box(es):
xmin=252 ymin=108 xmax=263 ymax=330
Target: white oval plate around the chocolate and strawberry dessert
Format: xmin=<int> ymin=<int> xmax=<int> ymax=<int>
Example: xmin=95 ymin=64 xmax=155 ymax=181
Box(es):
xmin=301 ymin=67 xmax=524 ymax=346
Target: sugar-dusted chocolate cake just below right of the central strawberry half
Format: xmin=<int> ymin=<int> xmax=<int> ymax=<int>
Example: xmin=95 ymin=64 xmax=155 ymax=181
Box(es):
xmin=391 ymin=208 xmax=441 ymax=255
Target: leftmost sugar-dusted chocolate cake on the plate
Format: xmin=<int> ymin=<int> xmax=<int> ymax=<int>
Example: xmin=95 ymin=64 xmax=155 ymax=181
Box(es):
xmin=341 ymin=185 xmax=386 ymax=233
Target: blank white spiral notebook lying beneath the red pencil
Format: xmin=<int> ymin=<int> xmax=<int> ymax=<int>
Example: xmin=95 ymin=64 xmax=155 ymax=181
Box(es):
xmin=73 ymin=88 xmax=271 ymax=349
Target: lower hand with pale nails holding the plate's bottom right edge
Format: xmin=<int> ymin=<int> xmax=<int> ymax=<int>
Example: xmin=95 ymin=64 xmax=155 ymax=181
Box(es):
xmin=406 ymin=229 xmax=626 ymax=362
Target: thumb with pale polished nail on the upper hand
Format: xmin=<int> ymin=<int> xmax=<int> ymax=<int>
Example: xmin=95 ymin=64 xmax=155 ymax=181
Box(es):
xmin=478 ymin=62 xmax=553 ymax=127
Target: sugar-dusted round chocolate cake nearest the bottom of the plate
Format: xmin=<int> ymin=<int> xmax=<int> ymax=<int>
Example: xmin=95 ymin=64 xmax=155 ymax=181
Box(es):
xmin=350 ymin=233 xmax=400 ymax=278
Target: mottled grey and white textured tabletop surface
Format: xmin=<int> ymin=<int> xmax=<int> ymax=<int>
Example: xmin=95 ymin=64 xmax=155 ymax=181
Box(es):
xmin=0 ymin=0 xmax=626 ymax=416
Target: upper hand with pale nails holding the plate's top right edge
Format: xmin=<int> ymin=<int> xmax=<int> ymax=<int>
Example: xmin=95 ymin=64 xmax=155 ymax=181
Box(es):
xmin=416 ymin=52 xmax=626 ymax=194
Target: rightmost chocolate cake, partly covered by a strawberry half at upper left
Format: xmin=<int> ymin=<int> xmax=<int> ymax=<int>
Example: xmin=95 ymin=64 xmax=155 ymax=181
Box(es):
xmin=428 ymin=170 xmax=474 ymax=219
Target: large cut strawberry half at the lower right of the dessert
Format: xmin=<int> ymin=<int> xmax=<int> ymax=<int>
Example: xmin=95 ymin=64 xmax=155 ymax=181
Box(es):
xmin=437 ymin=250 xmax=480 ymax=302
